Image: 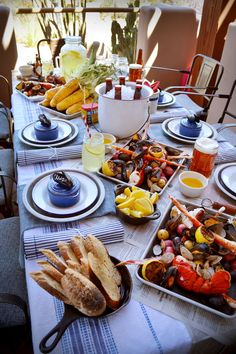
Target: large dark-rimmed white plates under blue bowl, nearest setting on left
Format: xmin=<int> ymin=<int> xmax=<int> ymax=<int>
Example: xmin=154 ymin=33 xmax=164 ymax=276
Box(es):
xmin=23 ymin=169 xmax=105 ymax=222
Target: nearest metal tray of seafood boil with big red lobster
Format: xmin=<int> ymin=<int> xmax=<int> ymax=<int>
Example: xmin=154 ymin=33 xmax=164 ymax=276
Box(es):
xmin=133 ymin=196 xmax=236 ymax=318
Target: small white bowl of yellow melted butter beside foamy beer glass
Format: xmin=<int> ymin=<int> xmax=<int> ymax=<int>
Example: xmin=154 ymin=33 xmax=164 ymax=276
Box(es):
xmin=179 ymin=171 xmax=208 ymax=198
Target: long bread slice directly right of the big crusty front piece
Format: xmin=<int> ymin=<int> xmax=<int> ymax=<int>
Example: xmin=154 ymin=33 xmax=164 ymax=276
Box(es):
xmin=88 ymin=252 xmax=121 ymax=309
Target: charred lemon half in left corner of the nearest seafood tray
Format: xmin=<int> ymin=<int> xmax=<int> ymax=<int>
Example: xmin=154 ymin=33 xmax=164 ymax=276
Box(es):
xmin=142 ymin=259 xmax=166 ymax=284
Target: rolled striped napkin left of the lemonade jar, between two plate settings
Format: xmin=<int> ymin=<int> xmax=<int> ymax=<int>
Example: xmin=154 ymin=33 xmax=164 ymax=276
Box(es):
xmin=17 ymin=145 xmax=82 ymax=166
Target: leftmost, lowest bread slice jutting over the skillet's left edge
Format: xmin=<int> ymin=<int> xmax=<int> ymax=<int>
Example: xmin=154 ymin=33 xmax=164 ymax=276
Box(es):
xmin=30 ymin=270 xmax=70 ymax=304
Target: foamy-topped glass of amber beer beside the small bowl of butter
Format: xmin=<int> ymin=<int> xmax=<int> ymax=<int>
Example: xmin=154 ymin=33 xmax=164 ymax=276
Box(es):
xmin=190 ymin=138 xmax=219 ymax=178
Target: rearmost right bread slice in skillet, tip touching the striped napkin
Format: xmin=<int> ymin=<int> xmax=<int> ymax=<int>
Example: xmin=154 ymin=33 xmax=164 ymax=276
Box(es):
xmin=84 ymin=235 xmax=121 ymax=285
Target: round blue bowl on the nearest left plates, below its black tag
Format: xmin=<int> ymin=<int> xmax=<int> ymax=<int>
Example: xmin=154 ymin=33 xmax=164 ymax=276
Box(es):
xmin=47 ymin=176 xmax=80 ymax=208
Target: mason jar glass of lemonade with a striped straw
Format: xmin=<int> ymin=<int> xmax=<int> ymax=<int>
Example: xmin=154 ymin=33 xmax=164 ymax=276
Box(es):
xmin=82 ymin=132 xmax=105 ymax=172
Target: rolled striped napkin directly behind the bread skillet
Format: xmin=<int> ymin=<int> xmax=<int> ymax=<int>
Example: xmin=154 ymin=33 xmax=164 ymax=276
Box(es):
xmin=24 ymin=220 xmax=124 ymax=259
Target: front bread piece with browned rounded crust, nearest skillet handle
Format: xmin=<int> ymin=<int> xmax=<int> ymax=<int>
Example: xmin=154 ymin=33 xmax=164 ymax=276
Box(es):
xmin=61 ymin=268 xmax=106 ymax=316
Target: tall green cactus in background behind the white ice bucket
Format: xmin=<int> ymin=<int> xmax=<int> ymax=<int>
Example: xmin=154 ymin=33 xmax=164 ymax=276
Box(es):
xmin=111 ymin=0 xmax=140 ymax=63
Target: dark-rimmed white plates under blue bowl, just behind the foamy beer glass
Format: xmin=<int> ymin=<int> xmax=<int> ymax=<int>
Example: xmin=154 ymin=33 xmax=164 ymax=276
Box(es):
xmin=162 ymin=117 xmax=217 ymax=144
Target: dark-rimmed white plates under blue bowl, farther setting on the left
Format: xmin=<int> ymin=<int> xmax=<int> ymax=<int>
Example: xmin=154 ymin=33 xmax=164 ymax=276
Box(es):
xmin=18 ymin=122 xmax=79 ymax=148
